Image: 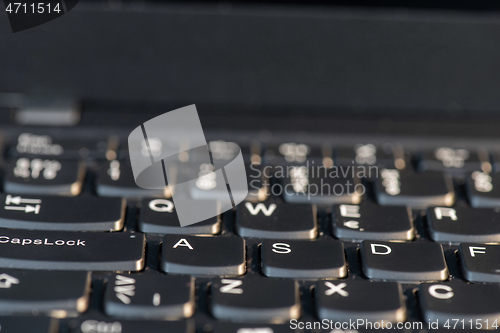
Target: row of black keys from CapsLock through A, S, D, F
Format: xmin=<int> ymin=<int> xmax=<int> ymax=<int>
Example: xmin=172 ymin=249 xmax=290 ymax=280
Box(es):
xmin=0 ymin=229 xmax=500 ymax=282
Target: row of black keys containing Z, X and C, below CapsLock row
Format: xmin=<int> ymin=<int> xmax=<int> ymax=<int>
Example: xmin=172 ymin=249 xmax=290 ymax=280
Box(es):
xmin=0 ymin=270 xmax=500 ymax=332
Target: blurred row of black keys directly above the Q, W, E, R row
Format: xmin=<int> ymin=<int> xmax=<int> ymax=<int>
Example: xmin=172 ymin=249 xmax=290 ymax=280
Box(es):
xmin=4 ymin=157 xmax=500 ymax=208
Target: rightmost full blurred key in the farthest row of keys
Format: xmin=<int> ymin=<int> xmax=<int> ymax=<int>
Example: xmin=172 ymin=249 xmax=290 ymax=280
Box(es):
xmin=415 ymin=147 xmax=491 ymax=173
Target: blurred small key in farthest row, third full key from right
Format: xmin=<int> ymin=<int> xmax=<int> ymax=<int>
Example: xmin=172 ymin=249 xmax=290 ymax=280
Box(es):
xmin=262 ymin=142 xmax=328 ymax=165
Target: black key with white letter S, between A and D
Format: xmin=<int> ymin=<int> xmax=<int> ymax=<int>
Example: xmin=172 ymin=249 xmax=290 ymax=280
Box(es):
xmin=261 ymin=238 xmax=347 ymax=279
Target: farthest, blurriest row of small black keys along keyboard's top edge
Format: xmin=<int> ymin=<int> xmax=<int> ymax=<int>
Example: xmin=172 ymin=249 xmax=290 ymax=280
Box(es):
xmin=7 ymin=133 xmax=500 ymax=172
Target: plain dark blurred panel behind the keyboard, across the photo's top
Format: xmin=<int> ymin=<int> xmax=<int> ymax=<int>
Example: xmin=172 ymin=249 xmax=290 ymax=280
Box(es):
xmin=0 ymin=1 xmax=500 ymax=117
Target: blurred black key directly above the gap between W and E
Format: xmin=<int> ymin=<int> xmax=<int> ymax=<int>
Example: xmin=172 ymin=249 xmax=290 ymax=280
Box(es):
xmin=280 ymin=166 xmax=366 ymax=205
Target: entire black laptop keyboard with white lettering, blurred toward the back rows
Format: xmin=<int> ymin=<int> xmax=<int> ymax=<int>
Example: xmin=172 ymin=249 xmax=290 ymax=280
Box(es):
xmin=0 ymin=133 xmax=500 ymax=333
